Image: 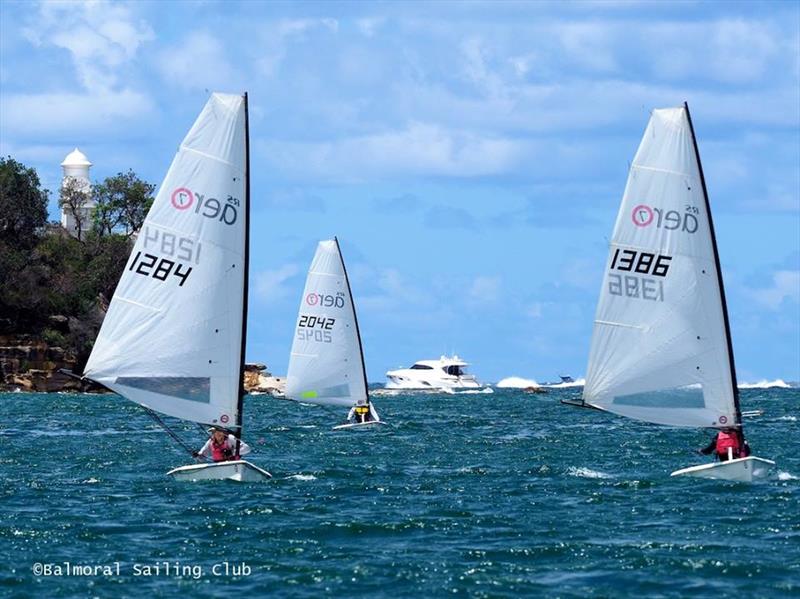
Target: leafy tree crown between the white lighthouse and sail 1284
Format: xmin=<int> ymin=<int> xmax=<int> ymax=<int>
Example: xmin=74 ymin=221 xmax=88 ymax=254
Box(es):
xmin=92 ymin=170 xmax=156 ymax=237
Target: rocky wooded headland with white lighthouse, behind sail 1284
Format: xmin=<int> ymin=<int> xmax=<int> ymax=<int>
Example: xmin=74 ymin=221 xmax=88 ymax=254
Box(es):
xmin=0 ymin=156 xmax=284 ymax=393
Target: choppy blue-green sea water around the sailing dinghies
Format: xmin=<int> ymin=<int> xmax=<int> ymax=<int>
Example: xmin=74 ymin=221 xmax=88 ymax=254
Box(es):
xmin=0 ymin=389 xmax=800 ymax=598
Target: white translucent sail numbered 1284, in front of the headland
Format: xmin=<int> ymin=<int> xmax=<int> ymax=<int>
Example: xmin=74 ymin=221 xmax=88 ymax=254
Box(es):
xmin=84 ymin=94 xmax=246 ymax=427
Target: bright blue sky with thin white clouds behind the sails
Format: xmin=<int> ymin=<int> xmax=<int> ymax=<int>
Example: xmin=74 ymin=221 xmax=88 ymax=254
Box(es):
xmin=0 ymin=1 xmax=800 ymax=382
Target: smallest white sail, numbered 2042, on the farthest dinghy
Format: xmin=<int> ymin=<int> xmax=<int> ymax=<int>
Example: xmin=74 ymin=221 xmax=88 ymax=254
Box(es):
xmin=286 ymin=240 xmax=368 ymax=406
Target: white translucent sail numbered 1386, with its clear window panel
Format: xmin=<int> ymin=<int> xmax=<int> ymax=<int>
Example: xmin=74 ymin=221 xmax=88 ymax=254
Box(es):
xmin=583 ymin=108 xmax=736 ymax=427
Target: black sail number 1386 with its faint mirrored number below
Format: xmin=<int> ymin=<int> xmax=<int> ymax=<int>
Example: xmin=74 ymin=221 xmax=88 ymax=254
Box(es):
xmin=608 ymin=248 xmax=672 ymax=302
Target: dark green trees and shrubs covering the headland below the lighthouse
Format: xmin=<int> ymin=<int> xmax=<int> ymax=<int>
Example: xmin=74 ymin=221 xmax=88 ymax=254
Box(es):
xmin=0 ymin=156 xmax=155 ymax=360
